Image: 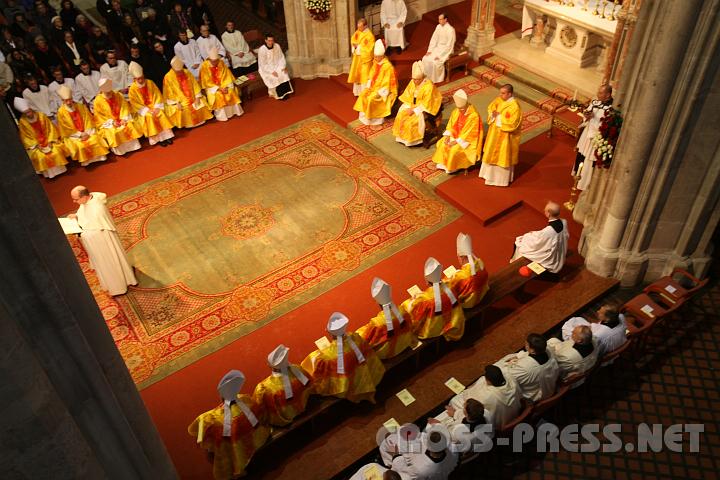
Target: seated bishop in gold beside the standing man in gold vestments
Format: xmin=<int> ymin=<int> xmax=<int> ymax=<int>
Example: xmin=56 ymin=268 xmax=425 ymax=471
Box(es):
xmin=433 ymin=89 xmax=483 ymax=173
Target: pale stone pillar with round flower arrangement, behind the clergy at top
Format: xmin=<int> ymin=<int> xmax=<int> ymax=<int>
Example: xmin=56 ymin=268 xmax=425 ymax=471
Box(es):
xmin=283 ymin=0 xmax=357 ymax=79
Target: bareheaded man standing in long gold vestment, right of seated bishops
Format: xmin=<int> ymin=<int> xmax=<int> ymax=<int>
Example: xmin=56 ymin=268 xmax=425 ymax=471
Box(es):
xmin=480 ymin=83 xmax=522 ymax=187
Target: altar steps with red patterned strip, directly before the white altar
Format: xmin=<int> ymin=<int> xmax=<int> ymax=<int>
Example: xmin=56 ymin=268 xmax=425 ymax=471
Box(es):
xmin=472 ymin=54 xmax=589 ymax=114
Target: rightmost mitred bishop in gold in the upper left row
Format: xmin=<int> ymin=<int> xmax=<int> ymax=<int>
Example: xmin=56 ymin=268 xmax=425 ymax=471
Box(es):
xmin=200 ymin=48 xmax=245 ymax=122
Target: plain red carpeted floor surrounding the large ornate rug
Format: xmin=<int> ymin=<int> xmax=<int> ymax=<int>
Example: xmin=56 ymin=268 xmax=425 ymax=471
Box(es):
xmin=35 ymin=2 xmax=579 ymax=480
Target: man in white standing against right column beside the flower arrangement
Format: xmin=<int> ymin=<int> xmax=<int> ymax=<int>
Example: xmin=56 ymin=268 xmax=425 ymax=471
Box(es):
xmin=572 ymin=85 xmax=613 ymax=190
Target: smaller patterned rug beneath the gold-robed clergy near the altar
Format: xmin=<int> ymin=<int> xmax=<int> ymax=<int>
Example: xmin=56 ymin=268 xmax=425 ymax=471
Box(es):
xmin=348 ymin=76 xmax=552 ymax=186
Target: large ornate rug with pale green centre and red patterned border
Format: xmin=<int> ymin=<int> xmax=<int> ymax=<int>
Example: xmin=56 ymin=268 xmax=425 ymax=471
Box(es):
xmin=76 ymin=116 xmax=459 ymax=388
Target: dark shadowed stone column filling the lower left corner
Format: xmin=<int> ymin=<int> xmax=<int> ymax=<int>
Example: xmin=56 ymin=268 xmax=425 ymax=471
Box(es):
xmin=0 ymin=108 xmax=177 ymax=480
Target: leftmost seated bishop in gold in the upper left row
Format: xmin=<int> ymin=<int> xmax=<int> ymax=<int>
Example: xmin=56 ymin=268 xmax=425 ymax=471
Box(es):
xmin=13 ymin=97 xmax=67 ymax=178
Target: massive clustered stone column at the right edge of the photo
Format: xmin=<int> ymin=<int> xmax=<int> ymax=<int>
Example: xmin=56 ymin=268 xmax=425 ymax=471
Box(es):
xmin=580 ymin=0 xmax=720 ymax=285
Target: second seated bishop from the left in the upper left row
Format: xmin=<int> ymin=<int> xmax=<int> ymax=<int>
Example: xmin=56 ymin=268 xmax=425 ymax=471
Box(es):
xmin=57 ymin=85 xmax=108 ymax=167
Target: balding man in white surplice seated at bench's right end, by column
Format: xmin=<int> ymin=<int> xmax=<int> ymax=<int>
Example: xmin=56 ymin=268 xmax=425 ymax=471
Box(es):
xmin=510 ymin=202 xmax=570 ymax=273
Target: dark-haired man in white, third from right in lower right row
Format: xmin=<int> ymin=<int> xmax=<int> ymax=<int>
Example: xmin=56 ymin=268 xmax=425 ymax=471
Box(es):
xmin=495 ymin=333 xmax=560 ymax=402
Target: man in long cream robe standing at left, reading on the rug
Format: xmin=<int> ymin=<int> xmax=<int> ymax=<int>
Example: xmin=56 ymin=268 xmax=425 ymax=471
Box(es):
xmin=68 ymin=185 xmax=138 ymax=295
